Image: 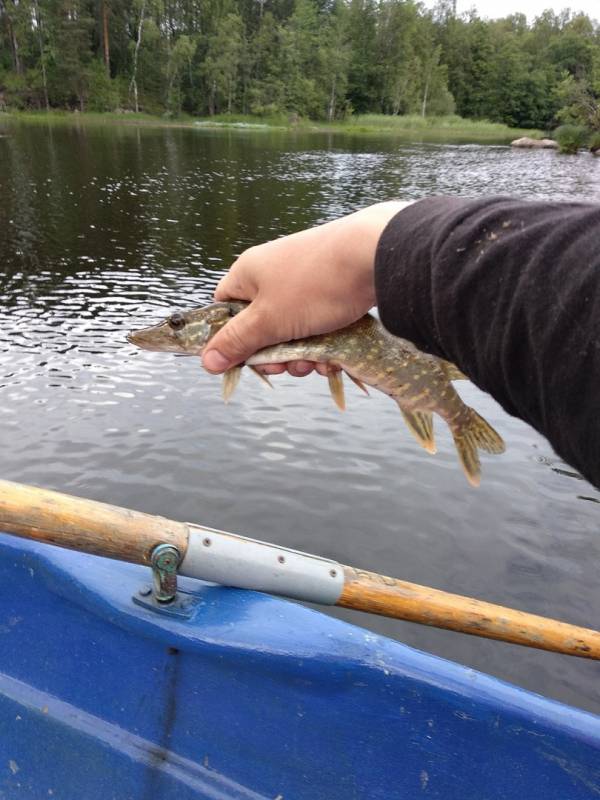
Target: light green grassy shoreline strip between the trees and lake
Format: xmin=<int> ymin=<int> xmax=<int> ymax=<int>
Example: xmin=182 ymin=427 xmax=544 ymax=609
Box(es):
xmin=0 ymin=111 xmax=543 ymax=144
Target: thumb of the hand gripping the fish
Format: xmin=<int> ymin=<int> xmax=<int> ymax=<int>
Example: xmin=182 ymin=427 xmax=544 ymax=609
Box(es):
xmin=202 ymin=303 xmax=279 ymax=372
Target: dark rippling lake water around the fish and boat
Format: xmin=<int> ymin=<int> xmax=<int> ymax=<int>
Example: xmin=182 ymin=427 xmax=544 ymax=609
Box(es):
xmin=0 ymin=121 xmax=600 ymax=712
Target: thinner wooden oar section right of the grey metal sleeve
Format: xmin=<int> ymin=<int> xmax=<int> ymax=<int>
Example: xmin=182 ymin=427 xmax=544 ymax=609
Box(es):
xmin=336 ymin=567 xmax=600 ymax=659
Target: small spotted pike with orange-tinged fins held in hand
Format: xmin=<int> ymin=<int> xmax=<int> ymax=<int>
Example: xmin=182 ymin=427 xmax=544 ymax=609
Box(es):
xmin=127 ymin=301 xmax=504 ymax=486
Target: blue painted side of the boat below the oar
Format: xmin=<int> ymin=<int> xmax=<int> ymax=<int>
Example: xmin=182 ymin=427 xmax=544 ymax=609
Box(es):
xmin=0 ymin=535 xmax=600 ymax=800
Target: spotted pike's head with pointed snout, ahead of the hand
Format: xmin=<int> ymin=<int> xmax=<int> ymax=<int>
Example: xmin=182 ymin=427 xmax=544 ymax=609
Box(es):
xmin=127 ymin=302 xmax=248 ymax=356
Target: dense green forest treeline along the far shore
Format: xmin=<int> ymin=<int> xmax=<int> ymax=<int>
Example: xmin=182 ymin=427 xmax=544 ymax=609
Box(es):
xmin=0 ymin=0 xmax=600 ymax=130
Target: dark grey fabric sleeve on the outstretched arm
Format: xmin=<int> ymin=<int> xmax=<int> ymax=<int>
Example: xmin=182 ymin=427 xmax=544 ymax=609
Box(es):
xmin=375 ymin=197 xmax=600 ymax=487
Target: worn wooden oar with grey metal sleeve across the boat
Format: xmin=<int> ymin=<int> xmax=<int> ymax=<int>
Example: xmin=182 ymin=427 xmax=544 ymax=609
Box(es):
xmin=0 ymin=481 xmax=600 ymax=659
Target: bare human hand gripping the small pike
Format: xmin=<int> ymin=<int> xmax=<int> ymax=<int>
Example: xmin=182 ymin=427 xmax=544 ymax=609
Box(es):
xmin=202 ymin=201 xmax=409 ymax=376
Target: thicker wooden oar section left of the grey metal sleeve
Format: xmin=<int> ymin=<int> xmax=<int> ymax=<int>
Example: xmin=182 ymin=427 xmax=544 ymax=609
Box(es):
xmin=0 ymin=481 xmax=188 ymax=564
